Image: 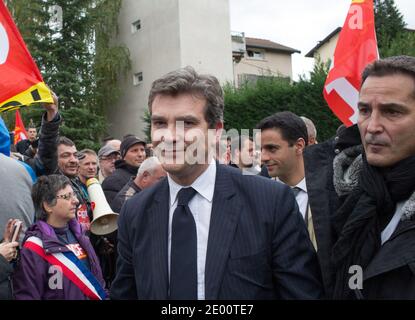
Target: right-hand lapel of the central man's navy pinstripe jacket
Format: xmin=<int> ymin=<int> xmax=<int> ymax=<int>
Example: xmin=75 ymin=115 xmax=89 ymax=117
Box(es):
xmin=205 ymin=163 xmax=241 ymax=300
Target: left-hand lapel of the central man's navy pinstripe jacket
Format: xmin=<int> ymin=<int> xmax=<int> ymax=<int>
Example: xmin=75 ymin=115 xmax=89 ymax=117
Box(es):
xmin=148 ymin=179 xmax=170 ymax=300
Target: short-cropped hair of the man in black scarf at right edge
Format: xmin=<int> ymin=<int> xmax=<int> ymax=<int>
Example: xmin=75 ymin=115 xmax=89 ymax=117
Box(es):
xmin=362 ymin=56 xmax=415 ymax=98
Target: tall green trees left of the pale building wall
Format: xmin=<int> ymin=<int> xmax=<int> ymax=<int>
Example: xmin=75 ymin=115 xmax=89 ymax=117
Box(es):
xmin=7 ymin=0 xmax=131 ymax=149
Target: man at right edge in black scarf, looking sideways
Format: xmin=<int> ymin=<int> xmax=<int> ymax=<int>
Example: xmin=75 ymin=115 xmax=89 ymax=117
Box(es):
xmin=326 ymin=56 xmax=415 ymax=299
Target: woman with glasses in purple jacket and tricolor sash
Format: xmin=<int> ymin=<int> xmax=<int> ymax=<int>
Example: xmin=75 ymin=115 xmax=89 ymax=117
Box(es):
xmin=13 ymin=174 xmax=107 ymax=300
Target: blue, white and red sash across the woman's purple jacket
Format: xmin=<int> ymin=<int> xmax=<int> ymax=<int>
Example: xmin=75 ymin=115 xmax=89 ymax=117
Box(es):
xmin=23 ymin=236 xmax=107 ymax=300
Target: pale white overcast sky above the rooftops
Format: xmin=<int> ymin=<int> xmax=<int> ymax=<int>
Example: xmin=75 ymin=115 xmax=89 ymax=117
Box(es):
xmin=229 ymin=0 xmax=415 ymax=80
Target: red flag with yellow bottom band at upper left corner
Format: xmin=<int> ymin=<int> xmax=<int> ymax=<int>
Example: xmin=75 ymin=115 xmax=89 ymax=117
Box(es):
xmin=0 ymin=1 xmax=53 ymax=112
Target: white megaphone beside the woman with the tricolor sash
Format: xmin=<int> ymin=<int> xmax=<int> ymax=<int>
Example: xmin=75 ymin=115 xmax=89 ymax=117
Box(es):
xmin=86 ymin=178 xmax=118 ymax=236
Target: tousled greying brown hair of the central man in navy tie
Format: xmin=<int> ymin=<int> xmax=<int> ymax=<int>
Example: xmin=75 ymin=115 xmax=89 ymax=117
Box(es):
xmin=148 ymin=66 xmax=224 ymax=128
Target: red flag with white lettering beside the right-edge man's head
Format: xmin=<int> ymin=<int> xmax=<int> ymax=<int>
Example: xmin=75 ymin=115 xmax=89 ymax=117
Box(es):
xmin=323 ymin=0 xmax=379 ymax=126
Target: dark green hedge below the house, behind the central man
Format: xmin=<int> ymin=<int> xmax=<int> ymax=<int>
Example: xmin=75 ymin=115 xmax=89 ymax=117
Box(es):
xmin=224 ymin=63 xmax=341 ymax=141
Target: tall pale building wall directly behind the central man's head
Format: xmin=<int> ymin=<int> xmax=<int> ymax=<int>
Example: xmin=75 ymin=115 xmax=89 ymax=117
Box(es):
xmin=108 ymin=0 xmax=232 ymax=138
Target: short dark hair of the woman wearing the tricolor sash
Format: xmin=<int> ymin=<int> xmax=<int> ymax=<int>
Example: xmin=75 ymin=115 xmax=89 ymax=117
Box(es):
xmin=32 ymin=174 xmax=71 ymax=221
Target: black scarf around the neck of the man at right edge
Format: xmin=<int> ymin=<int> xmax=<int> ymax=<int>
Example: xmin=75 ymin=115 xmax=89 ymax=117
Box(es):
xmin=332 ymin=153 xmax=415 ymax=299
